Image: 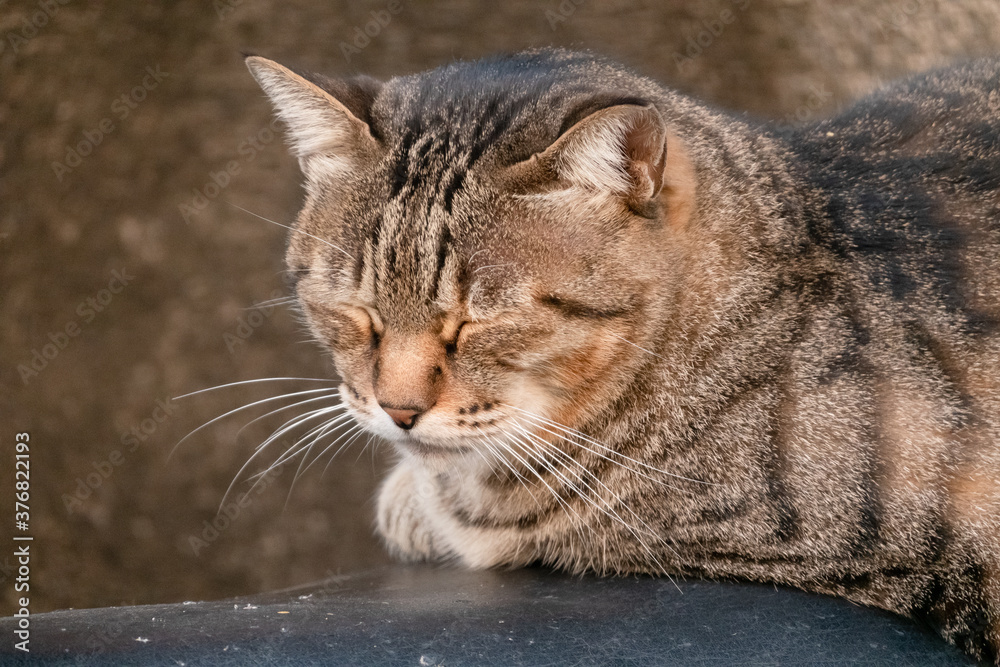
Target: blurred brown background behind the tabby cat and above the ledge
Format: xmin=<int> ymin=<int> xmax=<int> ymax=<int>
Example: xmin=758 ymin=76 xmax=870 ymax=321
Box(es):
xmin=0 ymin=0 xmax=1000 ymax=615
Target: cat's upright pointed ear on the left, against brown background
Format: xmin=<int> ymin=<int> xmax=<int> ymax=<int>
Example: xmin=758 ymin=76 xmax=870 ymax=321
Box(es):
xmin=246 ymin=56 xmax=381 ymax=182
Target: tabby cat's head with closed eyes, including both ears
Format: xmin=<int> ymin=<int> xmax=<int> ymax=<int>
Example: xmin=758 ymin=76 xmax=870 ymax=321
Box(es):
xmin=247 ymin=51 xmax=689 ymax=457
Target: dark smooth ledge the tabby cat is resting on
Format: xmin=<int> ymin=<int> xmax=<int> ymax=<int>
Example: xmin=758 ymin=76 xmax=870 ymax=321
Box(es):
xmin=0 ymin=567 xmax=971 ymax=667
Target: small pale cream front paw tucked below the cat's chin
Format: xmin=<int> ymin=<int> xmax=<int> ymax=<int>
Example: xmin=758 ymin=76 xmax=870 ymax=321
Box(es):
xmin=376 ymin=464 xmax=444 ymax=561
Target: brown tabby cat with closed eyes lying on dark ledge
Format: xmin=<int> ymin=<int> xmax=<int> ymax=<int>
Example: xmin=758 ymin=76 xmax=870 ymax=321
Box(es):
xmin=247 ymin=49 xmax=1000 ymax=662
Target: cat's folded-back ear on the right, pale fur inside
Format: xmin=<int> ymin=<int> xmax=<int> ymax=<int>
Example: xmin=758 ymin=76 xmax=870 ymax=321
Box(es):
xmin=515 ymin=104 xmax=667 ymax=209
